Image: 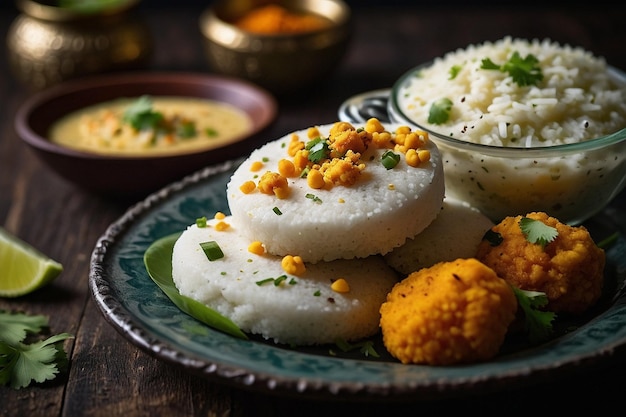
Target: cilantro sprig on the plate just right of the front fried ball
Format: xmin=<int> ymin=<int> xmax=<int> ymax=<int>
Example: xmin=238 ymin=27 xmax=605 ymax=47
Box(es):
xmin=511 ymin=286 xmax=556 ymax=343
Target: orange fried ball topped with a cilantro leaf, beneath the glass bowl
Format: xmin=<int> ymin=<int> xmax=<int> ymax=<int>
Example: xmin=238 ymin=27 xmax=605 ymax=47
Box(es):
xmin=476 ymin=212 xmax=605 ymax=314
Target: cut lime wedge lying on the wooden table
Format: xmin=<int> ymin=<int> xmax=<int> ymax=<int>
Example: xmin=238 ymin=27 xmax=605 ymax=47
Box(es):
xmin=0 ymin=227 xmax=63 ymax=297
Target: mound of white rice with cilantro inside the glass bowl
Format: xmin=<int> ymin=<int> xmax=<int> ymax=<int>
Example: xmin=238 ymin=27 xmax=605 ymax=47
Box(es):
xmin=397 ymin=37 xmax=626 ymax=147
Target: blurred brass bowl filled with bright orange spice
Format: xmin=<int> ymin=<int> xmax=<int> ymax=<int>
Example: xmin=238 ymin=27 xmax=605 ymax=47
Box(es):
xmin=200 ymin=0 xmax=351 ymax=94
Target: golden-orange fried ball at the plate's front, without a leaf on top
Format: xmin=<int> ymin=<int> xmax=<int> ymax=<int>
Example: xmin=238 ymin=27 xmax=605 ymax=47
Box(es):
xmin=380 ymin=258 xmax=517 ymax=365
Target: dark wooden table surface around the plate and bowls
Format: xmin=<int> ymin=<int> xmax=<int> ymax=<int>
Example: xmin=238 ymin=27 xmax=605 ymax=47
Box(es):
xmin=0 ymin=2 xmax=626 ymax=417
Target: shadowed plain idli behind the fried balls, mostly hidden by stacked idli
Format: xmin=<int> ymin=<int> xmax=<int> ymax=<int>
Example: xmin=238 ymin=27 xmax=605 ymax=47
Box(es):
xmin=385 ymin=197 xmax=494 ymax=275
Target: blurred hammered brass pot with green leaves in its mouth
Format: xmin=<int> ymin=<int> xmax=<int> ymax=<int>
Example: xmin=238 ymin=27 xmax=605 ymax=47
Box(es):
xmin=7 ymin=0 xmax=152 ymax=90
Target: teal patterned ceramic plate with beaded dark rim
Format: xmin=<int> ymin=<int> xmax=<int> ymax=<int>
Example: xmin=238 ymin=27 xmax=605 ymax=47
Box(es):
xmin=89 ymin=161 xmax=626 ymax=400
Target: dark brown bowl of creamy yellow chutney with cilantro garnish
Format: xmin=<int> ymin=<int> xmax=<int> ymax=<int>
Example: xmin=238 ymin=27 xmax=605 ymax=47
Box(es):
xmin=15 ymin=72 xmax=277 ymax=197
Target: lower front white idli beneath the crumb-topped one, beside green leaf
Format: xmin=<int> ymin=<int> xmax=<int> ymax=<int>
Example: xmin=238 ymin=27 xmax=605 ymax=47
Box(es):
xmin=172 ymin=216 xmax=398 ymax=345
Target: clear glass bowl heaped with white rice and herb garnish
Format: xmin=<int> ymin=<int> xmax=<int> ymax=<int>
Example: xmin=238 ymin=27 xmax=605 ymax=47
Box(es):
xmin=389 ymin=37 xmax=626 ymax=224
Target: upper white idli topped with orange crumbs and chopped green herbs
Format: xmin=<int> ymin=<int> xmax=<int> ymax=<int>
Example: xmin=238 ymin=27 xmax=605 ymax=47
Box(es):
xmin=227 ymin=119 xmax=444 ymax=262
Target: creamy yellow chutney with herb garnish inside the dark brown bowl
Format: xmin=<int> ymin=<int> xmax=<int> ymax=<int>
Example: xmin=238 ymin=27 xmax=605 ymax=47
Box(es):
xmin=50 ymin=96 xmax=252 ymax=156
